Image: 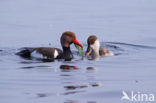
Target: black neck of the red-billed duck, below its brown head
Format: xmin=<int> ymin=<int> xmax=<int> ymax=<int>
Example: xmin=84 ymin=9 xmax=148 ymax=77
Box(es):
xmin=63 ymin=47 xmax=73 ymax=61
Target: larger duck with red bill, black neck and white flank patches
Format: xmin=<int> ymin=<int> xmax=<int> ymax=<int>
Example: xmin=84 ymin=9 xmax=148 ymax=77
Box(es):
xmin=16 ymin=31 xmax=83 ymax=61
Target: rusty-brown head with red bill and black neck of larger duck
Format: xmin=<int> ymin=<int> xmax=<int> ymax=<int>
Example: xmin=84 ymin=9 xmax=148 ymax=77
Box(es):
xmin=60 ymin=31 xmax=83 ymax=61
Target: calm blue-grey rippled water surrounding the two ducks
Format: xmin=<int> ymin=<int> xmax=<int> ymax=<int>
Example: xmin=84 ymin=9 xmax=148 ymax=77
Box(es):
xmin=0 ymin=0 xmax=156 ymax=103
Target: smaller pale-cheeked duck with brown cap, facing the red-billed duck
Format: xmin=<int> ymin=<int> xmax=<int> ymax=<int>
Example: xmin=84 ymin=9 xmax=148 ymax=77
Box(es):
xmin=85 ymin=35 xmax=114 ymax=59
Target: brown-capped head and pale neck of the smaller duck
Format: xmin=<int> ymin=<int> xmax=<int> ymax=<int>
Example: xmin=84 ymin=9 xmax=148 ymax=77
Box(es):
xmin=85 ymin=35 xmax=100 ymax=58
